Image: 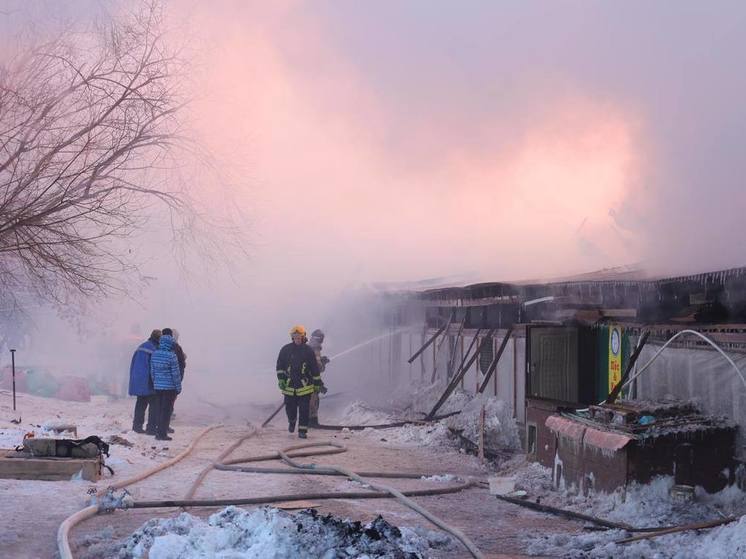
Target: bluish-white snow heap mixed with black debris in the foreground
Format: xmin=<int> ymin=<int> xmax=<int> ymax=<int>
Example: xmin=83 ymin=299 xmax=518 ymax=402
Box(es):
xmin=98 ymin=507 xmax=454 ymax=559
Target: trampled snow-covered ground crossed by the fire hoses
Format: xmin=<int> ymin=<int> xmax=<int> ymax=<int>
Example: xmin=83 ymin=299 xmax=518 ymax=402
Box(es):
xmin=13 ymin=387 xmax=746 ymax=559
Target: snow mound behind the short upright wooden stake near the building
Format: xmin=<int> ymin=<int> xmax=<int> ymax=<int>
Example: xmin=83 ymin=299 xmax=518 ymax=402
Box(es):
xmin=445 ymin=394 xmax=521 ymax=450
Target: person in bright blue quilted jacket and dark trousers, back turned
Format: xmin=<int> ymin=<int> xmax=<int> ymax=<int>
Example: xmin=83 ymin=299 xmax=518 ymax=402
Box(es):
xmin=150 ymin=335 xmax=181 ymax=441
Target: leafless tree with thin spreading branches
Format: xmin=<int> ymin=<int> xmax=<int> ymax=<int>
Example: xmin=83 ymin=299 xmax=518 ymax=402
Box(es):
xmin=0 ymin=3 xmax=194 ymax=304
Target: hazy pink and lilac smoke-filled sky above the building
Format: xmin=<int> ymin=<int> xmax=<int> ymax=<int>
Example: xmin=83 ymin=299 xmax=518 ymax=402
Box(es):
xmin=0 ymin=0 xmax=746 ymax=394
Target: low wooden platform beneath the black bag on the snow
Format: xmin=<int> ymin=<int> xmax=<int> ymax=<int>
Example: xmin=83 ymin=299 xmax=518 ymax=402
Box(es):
xmin=0 ymin=450 xmax=101 ymax=481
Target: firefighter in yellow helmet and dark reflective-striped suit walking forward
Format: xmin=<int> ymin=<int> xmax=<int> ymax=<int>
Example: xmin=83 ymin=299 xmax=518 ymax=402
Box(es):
xmin=277 ymin=326 xmax=321 ymax=439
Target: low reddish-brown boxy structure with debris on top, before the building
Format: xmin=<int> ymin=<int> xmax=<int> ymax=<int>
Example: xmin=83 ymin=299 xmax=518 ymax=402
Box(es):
xmin=529 ymin=402 xmax=736 ymax=493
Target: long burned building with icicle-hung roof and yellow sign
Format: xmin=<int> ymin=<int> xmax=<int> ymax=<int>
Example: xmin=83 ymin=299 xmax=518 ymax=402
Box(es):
xmin=389 ymin=268 xmax=746 ymax=494
